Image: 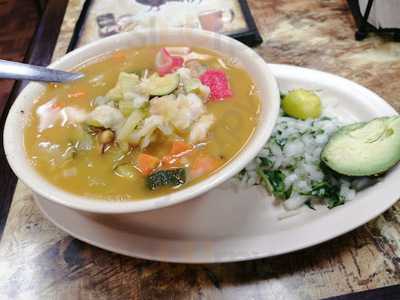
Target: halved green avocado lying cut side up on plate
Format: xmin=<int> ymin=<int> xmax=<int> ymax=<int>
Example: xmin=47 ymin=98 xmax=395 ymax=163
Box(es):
xmin=321 ymin=116 xmax=400 ymax=176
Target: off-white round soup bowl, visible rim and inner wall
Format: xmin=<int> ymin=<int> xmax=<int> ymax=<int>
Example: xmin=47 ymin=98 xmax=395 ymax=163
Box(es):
xmin=4 ymin=29 xmax=280 ymax=214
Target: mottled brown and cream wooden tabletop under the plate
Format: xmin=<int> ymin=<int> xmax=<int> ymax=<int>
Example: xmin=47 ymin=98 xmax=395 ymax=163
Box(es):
xmin=0 ymin=0 xmax=400 ymax=300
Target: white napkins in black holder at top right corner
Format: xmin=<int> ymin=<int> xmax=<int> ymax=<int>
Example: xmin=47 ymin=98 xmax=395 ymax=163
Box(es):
xmin=359 ymin=0 xmax=400 ymax=28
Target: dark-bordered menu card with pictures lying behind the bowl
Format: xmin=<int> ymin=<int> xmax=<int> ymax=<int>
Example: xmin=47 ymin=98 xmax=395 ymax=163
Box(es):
xmin=69 ymin=0 xmax=262 ymax=50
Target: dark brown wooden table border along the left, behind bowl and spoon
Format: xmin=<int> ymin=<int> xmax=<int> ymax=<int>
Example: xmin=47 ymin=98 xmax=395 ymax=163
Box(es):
xmin=0 ymin=0 xmax=68 ymax=237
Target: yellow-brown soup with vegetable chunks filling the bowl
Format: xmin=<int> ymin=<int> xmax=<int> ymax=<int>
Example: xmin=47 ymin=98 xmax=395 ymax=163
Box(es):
xmin=25 ymin=47 xmax=260 ymax=200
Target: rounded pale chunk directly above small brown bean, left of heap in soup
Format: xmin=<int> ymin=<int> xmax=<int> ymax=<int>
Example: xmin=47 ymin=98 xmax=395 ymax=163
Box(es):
xmin=86 ymin=105 xmax=125 ymax=130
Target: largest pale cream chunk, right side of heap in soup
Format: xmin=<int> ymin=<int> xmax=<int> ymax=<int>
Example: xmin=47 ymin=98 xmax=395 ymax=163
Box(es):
xmin=150 ymin=94 xmax=206 ymax=130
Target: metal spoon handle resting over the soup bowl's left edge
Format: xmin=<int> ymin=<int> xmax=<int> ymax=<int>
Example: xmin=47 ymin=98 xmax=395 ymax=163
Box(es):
xmin=0 ymin=59 xmax=85 ymax=82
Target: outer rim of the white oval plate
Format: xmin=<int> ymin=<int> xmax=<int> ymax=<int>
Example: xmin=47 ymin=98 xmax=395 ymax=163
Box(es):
xmin=35 ymin=64 xmax=400 ymax=264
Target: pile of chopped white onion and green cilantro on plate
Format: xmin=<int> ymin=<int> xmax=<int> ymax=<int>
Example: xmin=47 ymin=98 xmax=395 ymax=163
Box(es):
xmin=236 ymin=116 xmax=362 ymax=210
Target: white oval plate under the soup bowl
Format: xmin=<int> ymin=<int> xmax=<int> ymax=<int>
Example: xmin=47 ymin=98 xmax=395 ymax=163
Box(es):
xmin=36 ymin=65 xmax=400 ymax=263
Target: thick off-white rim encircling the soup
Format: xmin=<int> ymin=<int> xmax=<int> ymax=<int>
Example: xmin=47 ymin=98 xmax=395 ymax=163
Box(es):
xmin=3 ymin=28 xmax=280 ymax=214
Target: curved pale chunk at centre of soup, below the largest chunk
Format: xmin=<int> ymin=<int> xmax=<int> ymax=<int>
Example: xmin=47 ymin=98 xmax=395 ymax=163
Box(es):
xmin=129 ymin=116 xmax=173 ymax=148
